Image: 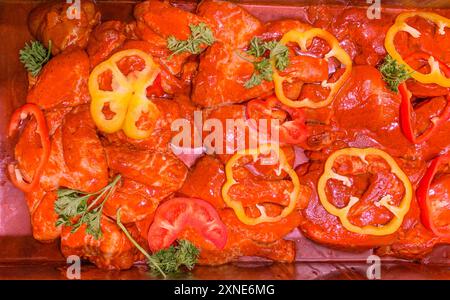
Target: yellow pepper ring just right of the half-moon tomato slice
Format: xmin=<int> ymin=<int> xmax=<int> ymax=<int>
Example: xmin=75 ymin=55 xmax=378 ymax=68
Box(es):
xmin=222 ymin=144 xmax=300 ymax=225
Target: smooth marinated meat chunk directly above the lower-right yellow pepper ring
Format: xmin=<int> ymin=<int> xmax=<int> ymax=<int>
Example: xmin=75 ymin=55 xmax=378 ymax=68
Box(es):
xmin=332 ymin=66 xmax=420 ymax=158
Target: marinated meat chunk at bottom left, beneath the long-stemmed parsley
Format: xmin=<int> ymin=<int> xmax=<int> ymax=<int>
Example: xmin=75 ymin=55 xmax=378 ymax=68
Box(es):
xmin=61 ymin=216 xmax=143 ymax=270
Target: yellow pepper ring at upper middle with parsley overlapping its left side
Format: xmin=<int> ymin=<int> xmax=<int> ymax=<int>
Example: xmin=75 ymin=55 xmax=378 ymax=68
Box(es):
xmin=272 ymin=28 xmax=352 ymax=108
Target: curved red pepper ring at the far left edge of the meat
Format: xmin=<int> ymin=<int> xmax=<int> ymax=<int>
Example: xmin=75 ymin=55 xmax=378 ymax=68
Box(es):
xmin=8 ymin=103 xmax=50 ymax=192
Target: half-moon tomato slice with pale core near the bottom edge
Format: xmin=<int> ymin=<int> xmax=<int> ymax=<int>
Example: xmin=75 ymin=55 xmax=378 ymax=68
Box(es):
xmin=148 ymin=198 xmax=227 ymax=252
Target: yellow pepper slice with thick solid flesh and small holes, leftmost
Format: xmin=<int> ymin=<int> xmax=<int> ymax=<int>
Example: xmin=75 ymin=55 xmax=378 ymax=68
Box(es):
xmin=89 ymin=49 xmax=160 ymax=139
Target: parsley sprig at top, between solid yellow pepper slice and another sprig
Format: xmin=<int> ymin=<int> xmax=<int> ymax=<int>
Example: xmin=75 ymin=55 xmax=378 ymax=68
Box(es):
xmin=167 ymin=23 xmax=215 ymax=57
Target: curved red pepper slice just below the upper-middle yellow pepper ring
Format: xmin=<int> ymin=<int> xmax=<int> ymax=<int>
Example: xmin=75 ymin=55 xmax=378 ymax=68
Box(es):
xmin=246 ymin=97 xmax=308 ymax=145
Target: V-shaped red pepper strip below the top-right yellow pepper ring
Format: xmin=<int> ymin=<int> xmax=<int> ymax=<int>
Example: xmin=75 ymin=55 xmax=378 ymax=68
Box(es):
xmin=398 ymin=83 xmax=450 ymax=144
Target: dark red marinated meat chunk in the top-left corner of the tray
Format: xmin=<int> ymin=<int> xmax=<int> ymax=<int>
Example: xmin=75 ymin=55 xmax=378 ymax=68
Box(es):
xmin=28 ymin=0 xmax=100 ymax=55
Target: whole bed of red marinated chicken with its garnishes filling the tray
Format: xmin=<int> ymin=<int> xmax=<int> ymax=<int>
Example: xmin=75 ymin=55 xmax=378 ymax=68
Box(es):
xmin=8 ymin=0 xmax=450 ymax=269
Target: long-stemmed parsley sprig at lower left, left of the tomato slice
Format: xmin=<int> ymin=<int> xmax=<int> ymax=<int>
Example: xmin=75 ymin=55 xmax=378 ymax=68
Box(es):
xmin=54 ymin=175 xmax=121 ymax=239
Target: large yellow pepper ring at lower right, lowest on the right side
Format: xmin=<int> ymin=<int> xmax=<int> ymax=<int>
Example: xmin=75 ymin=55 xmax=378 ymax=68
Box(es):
xmin=317 ymin=148 xmax=413 ymax=236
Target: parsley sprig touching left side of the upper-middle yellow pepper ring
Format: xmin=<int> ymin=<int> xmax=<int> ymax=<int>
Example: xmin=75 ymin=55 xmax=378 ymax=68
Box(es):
xmin=244 ymin=37 xmax=289 ymax=89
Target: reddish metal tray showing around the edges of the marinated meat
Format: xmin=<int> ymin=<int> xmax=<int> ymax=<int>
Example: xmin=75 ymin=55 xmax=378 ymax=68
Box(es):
xmin=0 ymin=0 xmax=450 ymax=280
